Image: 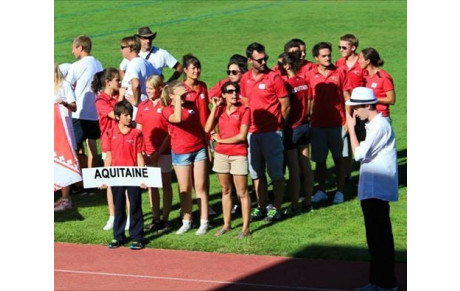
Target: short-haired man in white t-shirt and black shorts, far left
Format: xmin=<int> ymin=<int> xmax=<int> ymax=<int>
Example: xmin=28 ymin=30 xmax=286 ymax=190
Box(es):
xmin=66 ymin=35 xmax=102 ymax=168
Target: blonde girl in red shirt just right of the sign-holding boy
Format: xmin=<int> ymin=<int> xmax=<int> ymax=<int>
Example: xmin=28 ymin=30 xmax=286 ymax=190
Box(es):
xmin=136 ymin=75 xmax=172 ymax=232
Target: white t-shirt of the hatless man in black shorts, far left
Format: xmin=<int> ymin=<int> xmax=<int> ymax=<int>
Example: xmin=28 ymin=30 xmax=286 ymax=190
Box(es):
xmin=66 ymin=56 xmax=103 ymax=120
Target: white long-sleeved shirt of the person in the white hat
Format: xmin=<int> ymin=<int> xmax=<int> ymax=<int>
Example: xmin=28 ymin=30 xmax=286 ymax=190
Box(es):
xmin=355 ymin=113 xmax=398 ymax=201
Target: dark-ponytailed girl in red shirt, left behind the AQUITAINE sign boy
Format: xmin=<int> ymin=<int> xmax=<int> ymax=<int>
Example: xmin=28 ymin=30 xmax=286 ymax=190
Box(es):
xmin=91 ymin=68 xmax=122 ymax=230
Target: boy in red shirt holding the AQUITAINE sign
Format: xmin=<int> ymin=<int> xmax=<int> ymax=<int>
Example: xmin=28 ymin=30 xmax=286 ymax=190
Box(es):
xmin=101 ymin=100 xmax=147 ymax=250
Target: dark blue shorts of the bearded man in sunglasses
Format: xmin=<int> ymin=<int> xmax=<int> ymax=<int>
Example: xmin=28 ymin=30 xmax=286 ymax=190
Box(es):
xmin=248 ymin=131 xmax=284 ymax=181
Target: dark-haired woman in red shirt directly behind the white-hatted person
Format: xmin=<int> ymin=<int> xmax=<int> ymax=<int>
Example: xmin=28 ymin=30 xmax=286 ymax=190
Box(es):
xmin=358 ymin=48 xmax=396 ymax=121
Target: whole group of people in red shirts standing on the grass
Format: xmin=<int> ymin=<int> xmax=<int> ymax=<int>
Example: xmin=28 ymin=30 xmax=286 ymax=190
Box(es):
xmin=57 ymin=29 xmax=395 ymax=249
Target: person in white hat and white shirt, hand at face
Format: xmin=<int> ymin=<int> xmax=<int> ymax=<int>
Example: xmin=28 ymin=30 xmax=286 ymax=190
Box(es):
xmin=345 ymin=87 xmax=399 ymax=291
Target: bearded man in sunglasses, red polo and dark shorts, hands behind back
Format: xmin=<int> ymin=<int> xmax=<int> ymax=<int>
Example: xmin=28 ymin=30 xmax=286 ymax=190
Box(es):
xmin=240 ymin=42 xmax=291 ymax=222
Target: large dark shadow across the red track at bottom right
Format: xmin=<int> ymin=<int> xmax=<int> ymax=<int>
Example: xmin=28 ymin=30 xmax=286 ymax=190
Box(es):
xmin=214 ymin=245 xmax=407 ymax=290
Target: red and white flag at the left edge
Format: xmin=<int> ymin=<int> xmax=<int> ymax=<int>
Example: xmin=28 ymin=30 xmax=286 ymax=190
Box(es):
xmin=54 ymin=104 xmax=82 ymax=191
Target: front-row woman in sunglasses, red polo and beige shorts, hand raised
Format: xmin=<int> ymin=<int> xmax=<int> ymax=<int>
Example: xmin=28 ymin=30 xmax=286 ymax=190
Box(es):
xmin=205 ymin=81 xmax=251 ymax=239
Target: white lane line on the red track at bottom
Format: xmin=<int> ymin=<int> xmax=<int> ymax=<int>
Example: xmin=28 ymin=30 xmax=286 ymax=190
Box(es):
xmin=54 ymin=269 xmax=337 ymax=291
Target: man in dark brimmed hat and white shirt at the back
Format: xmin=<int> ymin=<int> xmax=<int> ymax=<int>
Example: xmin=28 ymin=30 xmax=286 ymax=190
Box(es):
xmin=119 ymin=26 xmax=182 ymax=82
